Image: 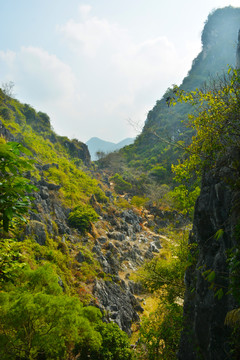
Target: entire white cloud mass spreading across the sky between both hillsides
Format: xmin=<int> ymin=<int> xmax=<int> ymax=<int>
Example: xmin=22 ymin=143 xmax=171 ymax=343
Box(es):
xmin=0 ymin=5 xmax=202 ymax=141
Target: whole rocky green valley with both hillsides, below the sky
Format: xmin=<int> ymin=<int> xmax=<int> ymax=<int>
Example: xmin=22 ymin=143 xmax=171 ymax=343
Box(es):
xmin=0 ymin=7 xmax=240 ymax=360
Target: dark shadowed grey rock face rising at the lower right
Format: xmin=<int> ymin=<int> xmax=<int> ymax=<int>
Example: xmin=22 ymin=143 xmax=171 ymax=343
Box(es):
xmin=178 ymin=153 xmax=240 ymax=360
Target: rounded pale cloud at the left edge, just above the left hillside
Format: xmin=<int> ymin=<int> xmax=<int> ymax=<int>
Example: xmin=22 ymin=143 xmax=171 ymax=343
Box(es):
xmin=0 ymin=47 xmax=81 ymax=137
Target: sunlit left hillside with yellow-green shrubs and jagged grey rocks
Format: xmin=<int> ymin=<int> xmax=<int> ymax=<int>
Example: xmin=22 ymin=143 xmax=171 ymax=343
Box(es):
xmin=0 ymin=90 xmax=176 ymax=340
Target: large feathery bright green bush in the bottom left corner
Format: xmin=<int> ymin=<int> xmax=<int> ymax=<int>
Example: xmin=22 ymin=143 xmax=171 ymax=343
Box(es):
xmin=0 ymin=266 xmax=101 ymax=360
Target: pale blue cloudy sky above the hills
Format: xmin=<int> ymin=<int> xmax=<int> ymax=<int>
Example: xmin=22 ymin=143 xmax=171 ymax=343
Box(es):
xmin=0 ymin=0 xmax=240 ymax=143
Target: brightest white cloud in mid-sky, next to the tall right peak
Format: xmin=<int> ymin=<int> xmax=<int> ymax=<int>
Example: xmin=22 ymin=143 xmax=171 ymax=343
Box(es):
xmin=57 ymin=7 xmax=192 ymax=128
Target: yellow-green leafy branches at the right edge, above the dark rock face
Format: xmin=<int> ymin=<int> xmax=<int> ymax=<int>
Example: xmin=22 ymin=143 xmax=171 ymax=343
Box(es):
xmin=173 ymin=69 xmax=240 ymax=183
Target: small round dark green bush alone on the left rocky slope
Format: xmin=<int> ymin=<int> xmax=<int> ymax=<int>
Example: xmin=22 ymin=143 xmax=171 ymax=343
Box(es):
xmin=68 ymin=204 xmax=98 ymax=233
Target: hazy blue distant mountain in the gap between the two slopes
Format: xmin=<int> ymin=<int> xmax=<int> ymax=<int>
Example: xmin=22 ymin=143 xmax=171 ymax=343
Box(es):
xmin=86 ymin=137 xmax=134 ymax=161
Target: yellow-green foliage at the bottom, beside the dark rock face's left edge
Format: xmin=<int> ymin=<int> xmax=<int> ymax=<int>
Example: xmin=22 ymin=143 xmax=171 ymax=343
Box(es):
xmin=138 ymin=231 xmax=191 ymax=360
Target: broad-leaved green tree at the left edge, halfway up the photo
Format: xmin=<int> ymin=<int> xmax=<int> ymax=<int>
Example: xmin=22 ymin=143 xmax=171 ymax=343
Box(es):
xmin=0 ymin=138 xmax=37 ymax=232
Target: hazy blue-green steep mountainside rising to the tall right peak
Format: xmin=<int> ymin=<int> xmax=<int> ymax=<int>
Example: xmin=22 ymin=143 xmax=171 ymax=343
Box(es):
xmin=121 ymin=7 xmax=240 ymax=182
